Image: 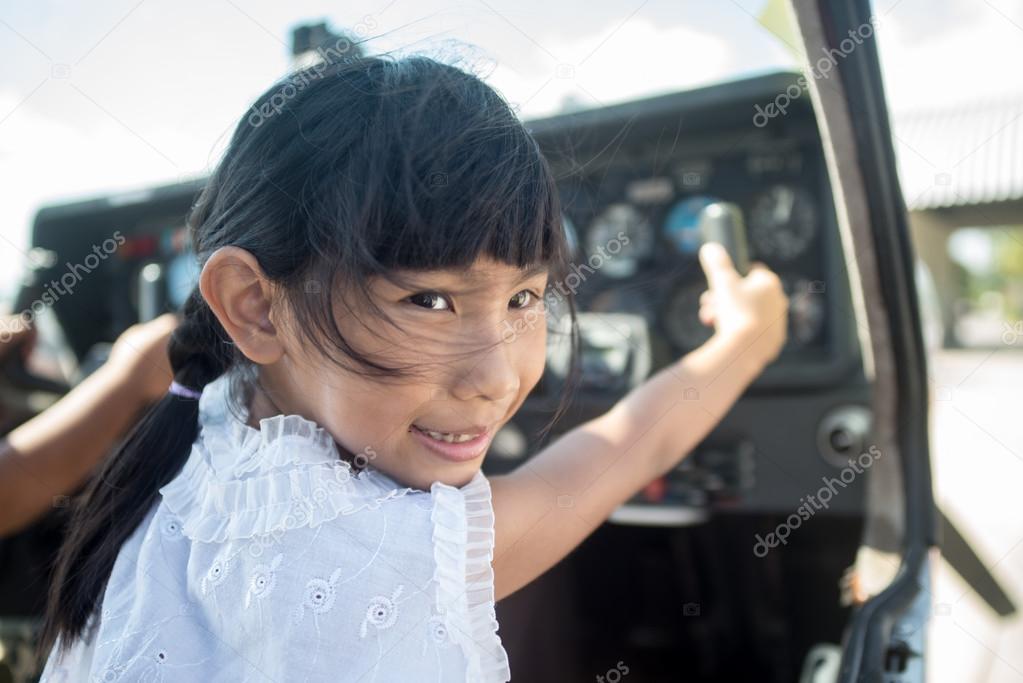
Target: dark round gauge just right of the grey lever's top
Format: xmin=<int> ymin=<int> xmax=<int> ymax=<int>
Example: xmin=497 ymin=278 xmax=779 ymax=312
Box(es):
xmin=750 ymin=185 xmax=817 ymax=261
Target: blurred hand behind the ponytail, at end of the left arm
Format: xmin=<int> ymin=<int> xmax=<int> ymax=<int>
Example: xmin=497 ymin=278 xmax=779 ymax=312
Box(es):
xmin=106 ymin=313 xmax=178 ymax=403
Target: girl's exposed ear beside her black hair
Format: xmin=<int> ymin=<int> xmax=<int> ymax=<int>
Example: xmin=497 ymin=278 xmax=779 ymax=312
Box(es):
xmin=198 ymin=246 xmax=284 ymax=365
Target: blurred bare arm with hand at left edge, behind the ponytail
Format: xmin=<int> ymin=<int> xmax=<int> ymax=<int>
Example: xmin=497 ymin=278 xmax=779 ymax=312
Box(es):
xmin=0 ymin=314 xmax=177 ymax=537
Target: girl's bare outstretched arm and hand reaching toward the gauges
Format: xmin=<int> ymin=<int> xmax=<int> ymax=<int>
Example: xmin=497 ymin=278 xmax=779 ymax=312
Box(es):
xmin=490 ymin=244 xmax=788 ymax=600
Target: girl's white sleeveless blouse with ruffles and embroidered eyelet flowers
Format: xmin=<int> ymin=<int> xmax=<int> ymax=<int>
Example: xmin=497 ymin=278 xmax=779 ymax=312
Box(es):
xmin=41 ymin=375 xmax=510 ymax=683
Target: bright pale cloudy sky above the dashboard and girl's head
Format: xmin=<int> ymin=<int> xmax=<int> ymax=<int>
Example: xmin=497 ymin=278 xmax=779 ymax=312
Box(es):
xmin=0 ymin=0 xmax=1023 ymax=300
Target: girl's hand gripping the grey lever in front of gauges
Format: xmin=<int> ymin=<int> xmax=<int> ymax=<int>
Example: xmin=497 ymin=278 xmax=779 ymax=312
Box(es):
xmin=700 ymin=242 xmax=789 ymax=365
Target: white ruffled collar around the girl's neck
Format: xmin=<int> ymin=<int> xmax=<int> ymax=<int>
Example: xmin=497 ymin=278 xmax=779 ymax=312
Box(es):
xmin=160 ymin=372 xmax=433 ymax=542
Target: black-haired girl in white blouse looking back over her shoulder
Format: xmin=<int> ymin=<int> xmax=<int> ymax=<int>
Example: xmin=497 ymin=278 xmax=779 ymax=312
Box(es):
xmin=31 ymin=50 xmax=788 ymax=681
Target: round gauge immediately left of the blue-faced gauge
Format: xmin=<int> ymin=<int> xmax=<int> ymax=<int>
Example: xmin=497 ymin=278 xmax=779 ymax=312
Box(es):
xmin=586 ymin=203 xmax=654 ymax=277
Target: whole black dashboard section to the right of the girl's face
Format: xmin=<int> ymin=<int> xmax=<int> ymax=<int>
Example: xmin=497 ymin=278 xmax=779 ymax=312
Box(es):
xmin=490 ymin=74 xmax=870 ymax=525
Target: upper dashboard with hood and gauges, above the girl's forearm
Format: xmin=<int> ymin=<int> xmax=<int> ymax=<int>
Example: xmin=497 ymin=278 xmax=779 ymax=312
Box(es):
xmin=532 ymin=74 xmax=858 ymax=393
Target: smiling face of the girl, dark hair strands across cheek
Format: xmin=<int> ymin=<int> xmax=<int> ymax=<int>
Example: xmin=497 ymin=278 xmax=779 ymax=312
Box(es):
xmin=263 ymin=258 xmax=548 ymax=491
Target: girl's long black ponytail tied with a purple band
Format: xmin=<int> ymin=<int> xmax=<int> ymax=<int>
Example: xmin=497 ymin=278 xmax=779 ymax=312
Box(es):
xmin=35 ymin=287 xmax=235 ymax=662
